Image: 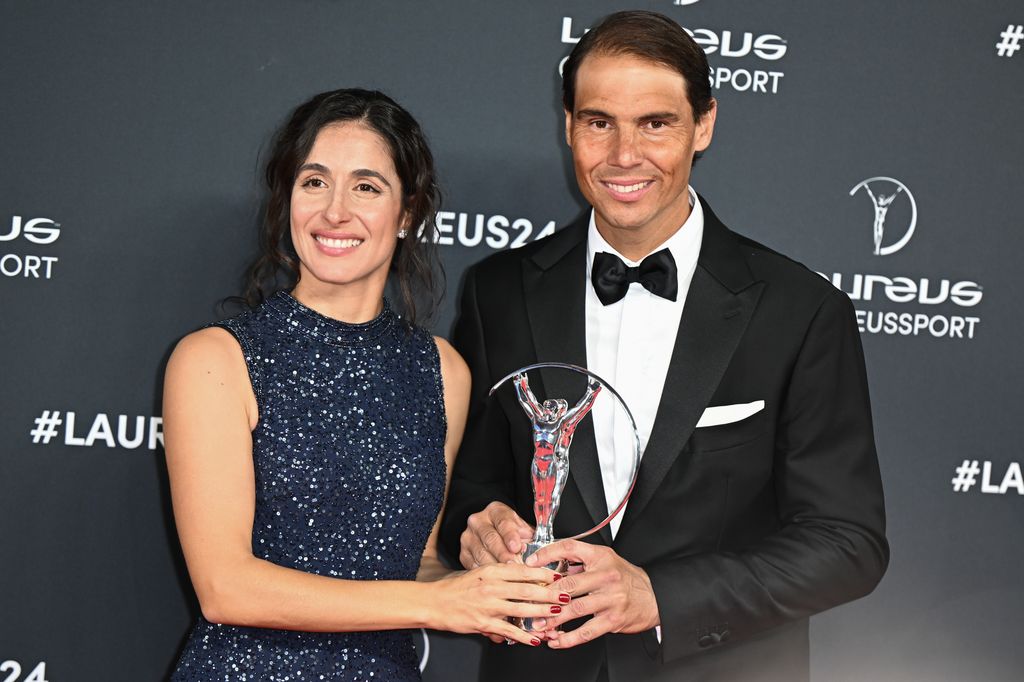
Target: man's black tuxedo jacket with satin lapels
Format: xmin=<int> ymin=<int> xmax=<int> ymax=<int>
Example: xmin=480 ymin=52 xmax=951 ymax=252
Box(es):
xmin=441 ymin=200 xmax=889 ymax=682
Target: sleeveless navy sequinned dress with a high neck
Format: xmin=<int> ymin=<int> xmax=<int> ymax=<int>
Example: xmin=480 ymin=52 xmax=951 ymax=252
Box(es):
xmin=171 ymin=292 xmax=446 ymax=682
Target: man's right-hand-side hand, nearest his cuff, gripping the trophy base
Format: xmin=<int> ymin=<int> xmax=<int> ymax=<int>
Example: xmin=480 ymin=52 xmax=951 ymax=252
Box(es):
xmin=526 ymin=540 xmax=660 ymax=649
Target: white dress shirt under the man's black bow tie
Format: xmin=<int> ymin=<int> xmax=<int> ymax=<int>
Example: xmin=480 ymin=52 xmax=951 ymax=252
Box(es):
xmin=586 ymin=187 xmax=703 ymax=538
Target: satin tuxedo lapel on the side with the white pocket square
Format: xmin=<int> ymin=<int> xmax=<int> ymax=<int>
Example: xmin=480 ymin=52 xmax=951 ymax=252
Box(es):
xmin=616 ymin=200 xmax=764 ymax=540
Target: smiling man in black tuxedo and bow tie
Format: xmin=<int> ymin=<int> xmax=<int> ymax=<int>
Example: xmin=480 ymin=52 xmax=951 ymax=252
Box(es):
xmin=442 ymin=11 xmax=889 ymax=682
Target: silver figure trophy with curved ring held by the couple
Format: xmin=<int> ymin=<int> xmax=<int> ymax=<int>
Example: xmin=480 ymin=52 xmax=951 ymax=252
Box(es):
xmin=489 ymin=363 xmax=640 ymax=631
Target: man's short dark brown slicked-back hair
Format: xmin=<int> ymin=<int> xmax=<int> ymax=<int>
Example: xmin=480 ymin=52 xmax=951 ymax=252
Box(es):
xmin=562 ymin=10 xmax=712 ymax=121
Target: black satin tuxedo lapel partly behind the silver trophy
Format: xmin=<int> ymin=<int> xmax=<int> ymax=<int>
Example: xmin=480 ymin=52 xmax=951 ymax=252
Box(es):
xmin=522 ymin=212 xmax=611 ymax=544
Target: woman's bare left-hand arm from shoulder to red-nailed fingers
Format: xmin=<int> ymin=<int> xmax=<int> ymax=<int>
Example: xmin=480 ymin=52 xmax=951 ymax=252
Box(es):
xmin=164 ymin=328 xmax=552 ymax=642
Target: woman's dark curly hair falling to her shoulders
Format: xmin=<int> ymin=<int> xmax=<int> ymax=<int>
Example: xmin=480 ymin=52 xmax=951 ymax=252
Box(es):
xmin=243 ymin=88 xmax=443 ymax=325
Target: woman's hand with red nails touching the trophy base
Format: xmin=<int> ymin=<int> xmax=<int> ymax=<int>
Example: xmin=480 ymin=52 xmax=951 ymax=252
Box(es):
xmin=431 ymin=563 xmax=569 ymax=646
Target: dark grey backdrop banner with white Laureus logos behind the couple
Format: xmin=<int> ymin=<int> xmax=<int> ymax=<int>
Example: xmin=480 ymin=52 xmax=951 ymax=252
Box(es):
xmin=0 ymin=0 xmax=1024 ymax=682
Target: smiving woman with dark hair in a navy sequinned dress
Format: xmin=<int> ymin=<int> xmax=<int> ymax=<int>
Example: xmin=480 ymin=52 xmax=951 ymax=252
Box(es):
xmin=164 ymin=90 xmax=566 ymax=680
